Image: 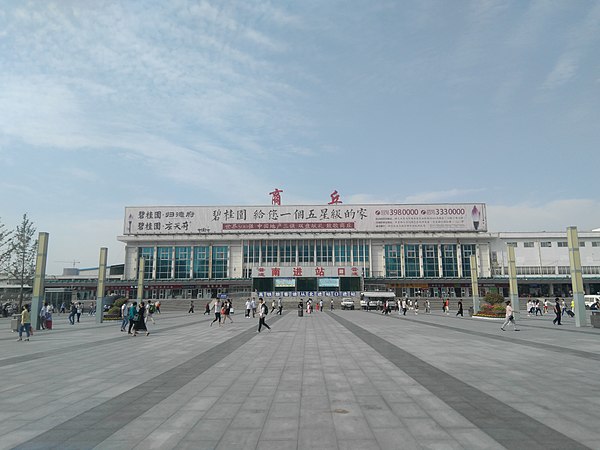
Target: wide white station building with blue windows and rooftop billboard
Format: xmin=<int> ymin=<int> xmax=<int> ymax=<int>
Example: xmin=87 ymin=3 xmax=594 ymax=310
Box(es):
xmin=109 ymin=203 xmax=600 ymax=298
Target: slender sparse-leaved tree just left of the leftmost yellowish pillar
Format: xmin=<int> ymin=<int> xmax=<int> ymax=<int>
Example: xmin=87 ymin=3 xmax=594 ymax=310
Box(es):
xmin=7 ymin=214 xmax=37 ymax=311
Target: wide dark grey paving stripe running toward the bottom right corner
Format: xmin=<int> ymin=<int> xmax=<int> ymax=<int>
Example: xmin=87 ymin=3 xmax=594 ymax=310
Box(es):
xmin=331 ymin=314 xmax=589 ymax=449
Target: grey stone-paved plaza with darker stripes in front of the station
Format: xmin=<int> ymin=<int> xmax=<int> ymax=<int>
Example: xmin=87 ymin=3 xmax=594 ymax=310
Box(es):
xmin=0 ymin=304 xmax=600 ymax=450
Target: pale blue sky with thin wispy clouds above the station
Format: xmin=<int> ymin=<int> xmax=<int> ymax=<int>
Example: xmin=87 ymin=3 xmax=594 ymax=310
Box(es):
xmin=0 ymin=0 xmax=600 ymax=274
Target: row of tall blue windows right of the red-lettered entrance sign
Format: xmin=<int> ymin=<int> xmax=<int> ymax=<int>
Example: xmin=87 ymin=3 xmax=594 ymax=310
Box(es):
xmin=385 ymin=244 xmax=475 ymax=278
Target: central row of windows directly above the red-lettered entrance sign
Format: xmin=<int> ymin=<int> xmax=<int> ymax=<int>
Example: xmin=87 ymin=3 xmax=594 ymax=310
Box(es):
xmin=244 ymin=239 xmax=369 ymax=266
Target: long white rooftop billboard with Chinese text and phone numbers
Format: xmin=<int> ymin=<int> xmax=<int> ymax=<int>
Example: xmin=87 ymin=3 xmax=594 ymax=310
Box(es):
xmin=124 ymin=203 xmax=487 ymax=235
